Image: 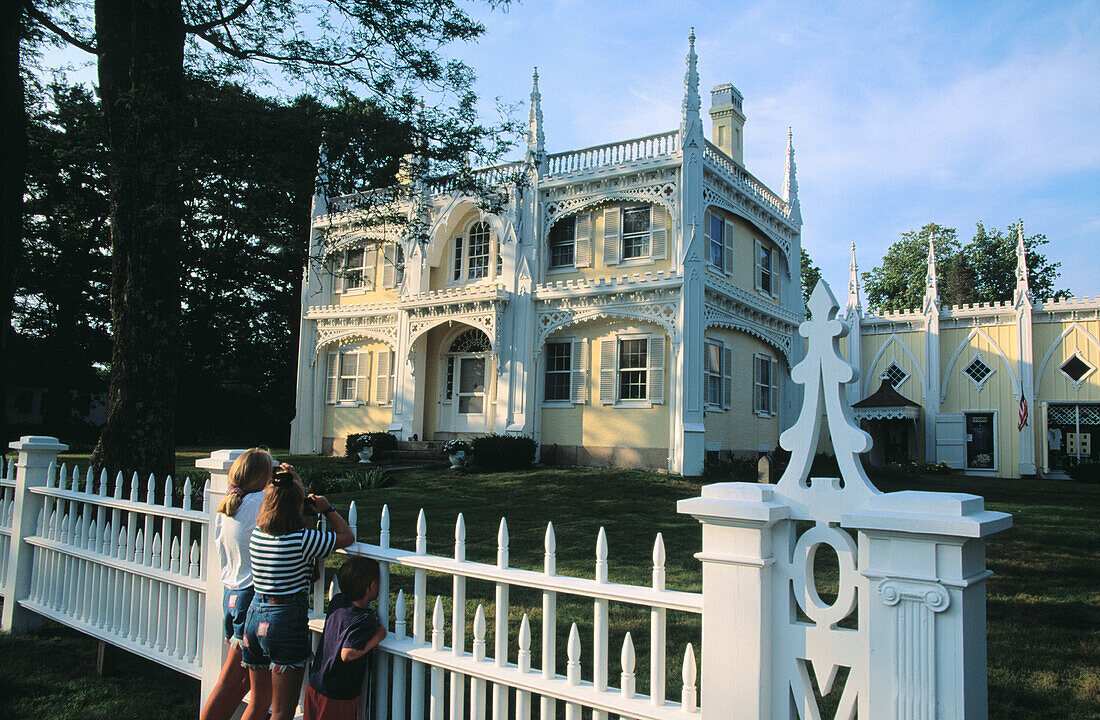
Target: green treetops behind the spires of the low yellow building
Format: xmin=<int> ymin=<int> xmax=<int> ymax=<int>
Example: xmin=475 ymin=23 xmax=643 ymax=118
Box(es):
xmin=862 ymin=222 xmax=1069 ymax=312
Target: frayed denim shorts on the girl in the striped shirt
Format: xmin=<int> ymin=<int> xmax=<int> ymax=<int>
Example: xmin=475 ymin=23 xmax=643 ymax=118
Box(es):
xmin=241 ymin=592 xmax=314 ymax=671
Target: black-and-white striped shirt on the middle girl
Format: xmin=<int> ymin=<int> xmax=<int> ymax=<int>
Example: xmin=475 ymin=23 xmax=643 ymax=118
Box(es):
xmin=249 ymin=528 xmax=337 ymax=595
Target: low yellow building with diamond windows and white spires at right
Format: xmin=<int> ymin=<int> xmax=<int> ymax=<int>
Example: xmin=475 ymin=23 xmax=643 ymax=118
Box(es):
xmin=845 ymin=236 xmax=1100 ymax=477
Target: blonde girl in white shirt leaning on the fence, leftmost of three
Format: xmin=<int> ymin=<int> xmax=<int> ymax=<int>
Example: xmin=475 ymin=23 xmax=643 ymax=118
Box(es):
xmin=199 ymin=447 xmax=275 ymax=720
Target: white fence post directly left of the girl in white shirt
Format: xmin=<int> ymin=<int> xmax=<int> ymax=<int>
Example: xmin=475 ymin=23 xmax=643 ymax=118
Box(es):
xmin=195 ymin=450 xmax=245 ymax=707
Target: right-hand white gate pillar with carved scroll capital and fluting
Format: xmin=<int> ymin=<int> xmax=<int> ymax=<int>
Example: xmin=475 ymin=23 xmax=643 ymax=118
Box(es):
xmin=843 ymin=491 xmax=1012 ymax=720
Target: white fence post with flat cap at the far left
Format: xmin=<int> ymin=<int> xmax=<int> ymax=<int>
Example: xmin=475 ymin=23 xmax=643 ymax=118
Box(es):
xmin=0 ymin=435 xmax=68 ymax=634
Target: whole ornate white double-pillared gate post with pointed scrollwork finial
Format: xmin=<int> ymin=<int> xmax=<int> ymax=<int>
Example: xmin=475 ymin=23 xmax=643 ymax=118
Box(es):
xmin=679 ymin=283 xmax=1012 ymax=720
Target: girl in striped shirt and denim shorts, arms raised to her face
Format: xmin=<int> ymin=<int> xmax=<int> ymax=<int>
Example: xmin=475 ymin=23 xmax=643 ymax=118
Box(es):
xmin=242 ymin=465 xmax=355 ymax=720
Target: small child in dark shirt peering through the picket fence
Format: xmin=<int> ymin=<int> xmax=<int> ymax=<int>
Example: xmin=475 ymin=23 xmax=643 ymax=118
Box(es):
xmin=305 ymin=557 xmax=386 ymax=720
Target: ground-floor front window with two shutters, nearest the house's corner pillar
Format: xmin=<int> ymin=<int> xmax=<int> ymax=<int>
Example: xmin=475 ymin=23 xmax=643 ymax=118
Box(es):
xmin=600 ymin=334 xmax=664 ymax=406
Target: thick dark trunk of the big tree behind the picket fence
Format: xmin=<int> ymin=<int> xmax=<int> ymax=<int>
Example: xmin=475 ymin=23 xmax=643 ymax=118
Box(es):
xmin=92 ymin=0 xmax=185 ymax=476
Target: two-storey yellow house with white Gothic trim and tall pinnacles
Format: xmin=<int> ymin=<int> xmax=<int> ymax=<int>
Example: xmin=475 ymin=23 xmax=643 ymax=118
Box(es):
xmin=290 ymin=35 xmax=804 ymax=475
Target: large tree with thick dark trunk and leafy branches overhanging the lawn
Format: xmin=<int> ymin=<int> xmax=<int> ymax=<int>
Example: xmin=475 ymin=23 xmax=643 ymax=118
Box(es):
xmin=18 ymin=0 xmax=506 ymax=473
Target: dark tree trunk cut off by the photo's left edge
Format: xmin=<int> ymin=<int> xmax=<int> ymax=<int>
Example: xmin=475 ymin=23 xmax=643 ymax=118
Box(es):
xmin=0 ymin=0 xmax=26 ymax=450
